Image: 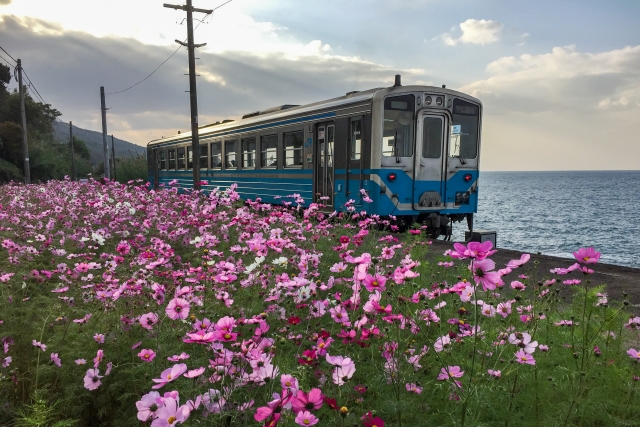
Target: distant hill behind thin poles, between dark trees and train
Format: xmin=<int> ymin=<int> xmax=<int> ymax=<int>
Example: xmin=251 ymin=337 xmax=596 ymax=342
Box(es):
xmin=53 ymin=120 xmax=147 ymax=166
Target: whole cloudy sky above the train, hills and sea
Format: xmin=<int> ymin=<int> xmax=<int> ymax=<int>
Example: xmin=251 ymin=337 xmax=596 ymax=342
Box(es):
xmin=0 ymin=0 xmax=640 ymax=171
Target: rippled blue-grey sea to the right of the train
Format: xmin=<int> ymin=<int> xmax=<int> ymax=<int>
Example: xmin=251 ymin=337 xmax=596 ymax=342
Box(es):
xmin=453 ymin=171 xmax=640 ymax=268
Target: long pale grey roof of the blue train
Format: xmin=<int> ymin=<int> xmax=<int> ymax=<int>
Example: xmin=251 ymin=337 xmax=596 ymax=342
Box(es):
xmin=147 ymin=85 xmax=482 ymax=146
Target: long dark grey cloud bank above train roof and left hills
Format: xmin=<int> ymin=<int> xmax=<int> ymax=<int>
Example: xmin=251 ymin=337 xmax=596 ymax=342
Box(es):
xmin=0 ymin=16 xmax=428 ymax=145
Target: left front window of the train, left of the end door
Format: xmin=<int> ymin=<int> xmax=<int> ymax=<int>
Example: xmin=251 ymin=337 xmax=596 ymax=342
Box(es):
xmin=382 ymin=95 xmax=416 ymax=157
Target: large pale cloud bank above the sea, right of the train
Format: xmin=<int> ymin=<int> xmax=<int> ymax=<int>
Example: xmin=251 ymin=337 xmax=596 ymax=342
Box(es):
xmin=460 ymin=46 xmax=640 ymax=170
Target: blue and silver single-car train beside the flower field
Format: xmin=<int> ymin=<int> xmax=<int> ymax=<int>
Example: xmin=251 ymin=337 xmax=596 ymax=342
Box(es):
xmin=147 ymin=75 xmax=482 ymax=239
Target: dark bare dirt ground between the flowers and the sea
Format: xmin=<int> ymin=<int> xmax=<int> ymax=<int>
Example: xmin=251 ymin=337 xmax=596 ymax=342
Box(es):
xmin=427 ymin=240 xmax=640 ymax=315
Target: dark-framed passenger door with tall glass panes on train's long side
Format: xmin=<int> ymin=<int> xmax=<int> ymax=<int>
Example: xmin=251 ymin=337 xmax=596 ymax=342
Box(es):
xmin=315 ymin=122 xmax=335 ymax=207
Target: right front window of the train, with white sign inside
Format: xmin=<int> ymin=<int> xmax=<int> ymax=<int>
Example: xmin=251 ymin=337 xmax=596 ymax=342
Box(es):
xmin=449 ymin=99 xmax=480 ymax=159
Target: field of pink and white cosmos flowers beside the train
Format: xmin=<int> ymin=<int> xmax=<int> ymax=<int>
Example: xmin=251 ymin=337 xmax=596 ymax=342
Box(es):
xmin=0 ymin=180 xmax=640 ymax=427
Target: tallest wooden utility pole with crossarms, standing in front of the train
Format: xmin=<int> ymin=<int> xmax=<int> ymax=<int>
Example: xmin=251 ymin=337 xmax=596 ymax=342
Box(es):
xmin=164 ymin=0 xmax=213 ymax=190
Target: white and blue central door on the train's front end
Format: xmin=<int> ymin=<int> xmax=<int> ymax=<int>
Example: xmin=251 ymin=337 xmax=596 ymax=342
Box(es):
xmin=413 ymin=112 xmax=449 ymax=210
